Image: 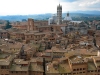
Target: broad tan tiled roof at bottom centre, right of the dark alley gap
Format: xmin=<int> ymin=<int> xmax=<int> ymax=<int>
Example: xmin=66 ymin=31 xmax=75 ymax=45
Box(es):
xmin=46 ymin=60 xmax=72 ymax=73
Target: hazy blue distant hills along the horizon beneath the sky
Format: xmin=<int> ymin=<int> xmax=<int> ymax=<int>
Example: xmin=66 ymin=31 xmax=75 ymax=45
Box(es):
xmin=0 ymin=11 xmax=100 ymax=21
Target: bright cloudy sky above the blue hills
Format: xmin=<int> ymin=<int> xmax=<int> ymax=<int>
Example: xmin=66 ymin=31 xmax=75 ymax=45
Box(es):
xmin=0 ymin=0 xmax=100 ymax=15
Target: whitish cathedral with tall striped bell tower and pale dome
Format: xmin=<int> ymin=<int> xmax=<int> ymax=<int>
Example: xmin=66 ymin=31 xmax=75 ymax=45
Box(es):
xmin=48 ymin=4 xmax=72 ymax=25
